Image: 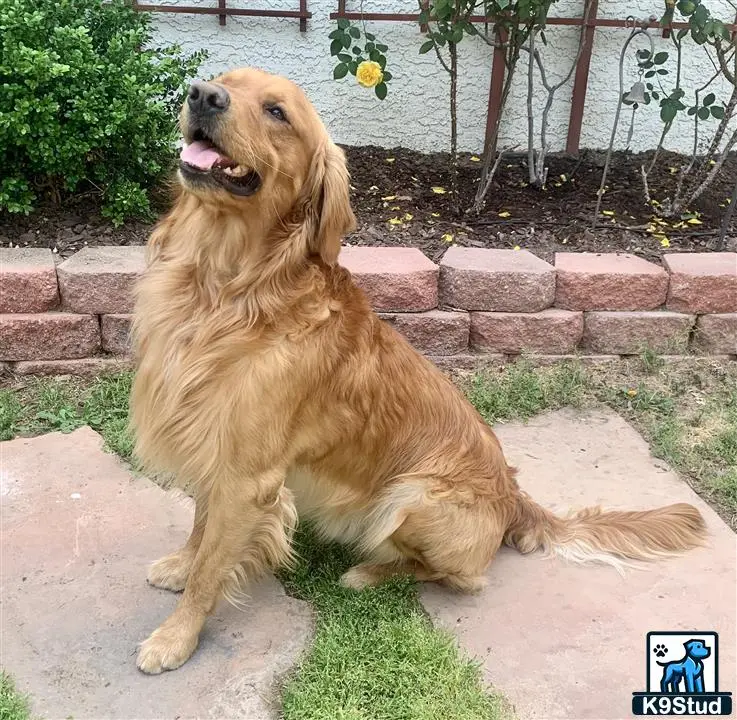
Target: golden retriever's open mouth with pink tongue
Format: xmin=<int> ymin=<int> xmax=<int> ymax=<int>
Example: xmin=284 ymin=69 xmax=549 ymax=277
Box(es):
xmin=179 ymin=133 xmax=261 ymax=196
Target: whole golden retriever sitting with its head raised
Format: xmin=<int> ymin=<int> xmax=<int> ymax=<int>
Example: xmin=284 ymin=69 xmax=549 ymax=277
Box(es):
xmin=131 ymin=69 xmax=705 ymax=673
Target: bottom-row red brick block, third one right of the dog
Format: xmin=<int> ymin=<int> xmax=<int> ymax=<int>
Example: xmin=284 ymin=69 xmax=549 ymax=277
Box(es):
xmin=583 ymin=310 xmax=696 ymax=355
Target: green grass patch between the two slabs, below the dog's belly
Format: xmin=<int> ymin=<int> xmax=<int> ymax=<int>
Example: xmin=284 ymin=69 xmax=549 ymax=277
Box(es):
xmin=281 ymin=530 xmax=512 ymax=720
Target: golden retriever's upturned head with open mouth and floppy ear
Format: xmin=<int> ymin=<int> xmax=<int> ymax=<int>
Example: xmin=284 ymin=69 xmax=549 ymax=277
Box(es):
xmin=179 ymin=68 xmax=355 ymax=263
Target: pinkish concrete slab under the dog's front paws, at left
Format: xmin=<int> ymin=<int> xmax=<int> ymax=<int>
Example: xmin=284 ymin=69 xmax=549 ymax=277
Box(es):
xmin=0 ymin=428 xmax=312 ymax=720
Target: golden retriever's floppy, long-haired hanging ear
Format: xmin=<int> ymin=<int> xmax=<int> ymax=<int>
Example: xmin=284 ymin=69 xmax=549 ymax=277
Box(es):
xmin=307 ymin=138 xmax=356 ymax=265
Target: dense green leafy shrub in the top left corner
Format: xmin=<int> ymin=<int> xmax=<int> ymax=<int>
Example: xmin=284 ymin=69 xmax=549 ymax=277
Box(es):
xmin=0 ymin=0 xmax=205 ymax=224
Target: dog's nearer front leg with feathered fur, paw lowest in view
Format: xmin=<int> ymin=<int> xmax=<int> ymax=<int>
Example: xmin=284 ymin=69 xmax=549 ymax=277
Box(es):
xmin=136 ymin=470 xmax=294 ymax=673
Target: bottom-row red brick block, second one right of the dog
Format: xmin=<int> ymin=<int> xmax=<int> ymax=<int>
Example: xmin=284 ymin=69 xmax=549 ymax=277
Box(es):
xmin=471 ymin=308 xmax=583 ymax=354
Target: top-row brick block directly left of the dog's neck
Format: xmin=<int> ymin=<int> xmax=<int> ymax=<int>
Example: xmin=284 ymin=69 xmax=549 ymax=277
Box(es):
xmin=57 ymin=246 xmax=145 ymax=315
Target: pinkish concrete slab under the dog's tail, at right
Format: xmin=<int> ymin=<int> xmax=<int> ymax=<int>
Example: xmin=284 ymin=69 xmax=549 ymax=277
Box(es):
xmin=422 ymin=410 xmax=737 ymax=720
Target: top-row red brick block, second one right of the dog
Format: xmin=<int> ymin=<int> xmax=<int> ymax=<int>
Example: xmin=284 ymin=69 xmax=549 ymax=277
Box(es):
xmin=440 ymin=247 xmax=555 ymax=312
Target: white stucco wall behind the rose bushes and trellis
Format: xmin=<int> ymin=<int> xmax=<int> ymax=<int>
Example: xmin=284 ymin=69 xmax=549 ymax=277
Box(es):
xmin=147 ymin=0 xmax=734 ymax=152
